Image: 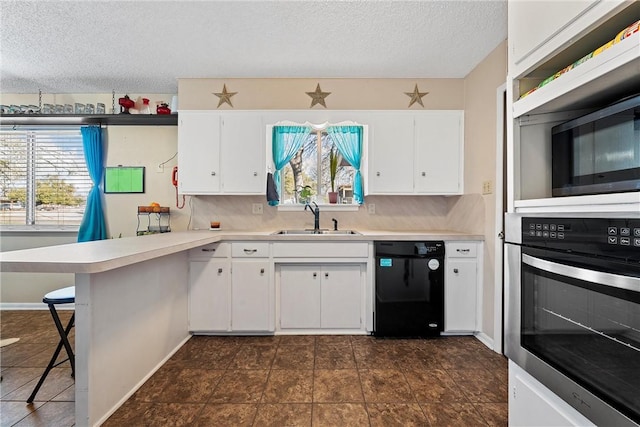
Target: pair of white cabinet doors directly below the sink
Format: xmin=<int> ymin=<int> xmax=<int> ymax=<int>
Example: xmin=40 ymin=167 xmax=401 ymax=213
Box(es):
xmin=280 ymin=264 xmax=363 ymax=329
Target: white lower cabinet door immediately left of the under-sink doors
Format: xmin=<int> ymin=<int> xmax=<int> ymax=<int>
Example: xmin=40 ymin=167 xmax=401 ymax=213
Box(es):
xmin=231 ymin=259 xmax=273 ymax=331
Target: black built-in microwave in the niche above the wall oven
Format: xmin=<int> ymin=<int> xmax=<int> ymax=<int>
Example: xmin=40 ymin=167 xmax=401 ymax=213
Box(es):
xmin=551 ymin=95 xmax=640 ymax=196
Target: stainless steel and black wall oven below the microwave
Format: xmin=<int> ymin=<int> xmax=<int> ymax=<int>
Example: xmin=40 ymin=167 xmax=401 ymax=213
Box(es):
xmin=505 ymin=214 xmax=640 ymax=425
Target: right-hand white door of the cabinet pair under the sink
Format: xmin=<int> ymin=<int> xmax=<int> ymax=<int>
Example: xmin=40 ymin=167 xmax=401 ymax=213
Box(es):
xmin=320 ymin=265 xmax=362 ymax=329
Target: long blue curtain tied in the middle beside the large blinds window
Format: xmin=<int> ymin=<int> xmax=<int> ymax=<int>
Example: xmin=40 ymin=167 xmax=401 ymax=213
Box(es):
xmin=78 ymin=126 xmax=107 ymax=242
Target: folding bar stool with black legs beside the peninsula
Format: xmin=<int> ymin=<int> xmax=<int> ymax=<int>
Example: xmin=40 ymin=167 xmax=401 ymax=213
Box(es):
xmin=27 ymin=286 xmax=76 ymax=403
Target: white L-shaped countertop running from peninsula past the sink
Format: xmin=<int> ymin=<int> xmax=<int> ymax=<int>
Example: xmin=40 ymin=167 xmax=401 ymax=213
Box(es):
xmin=0 ymin=230 xmax=484 ymax=273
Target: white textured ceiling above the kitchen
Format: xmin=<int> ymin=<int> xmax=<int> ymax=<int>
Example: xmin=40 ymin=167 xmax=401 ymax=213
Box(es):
xmin=0 ymin=0 xmax=507 ymax=93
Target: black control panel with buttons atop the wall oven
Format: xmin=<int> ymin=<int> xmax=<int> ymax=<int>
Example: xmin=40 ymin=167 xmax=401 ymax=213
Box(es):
xmin=522 ymin=217 xmax=640 ymax=260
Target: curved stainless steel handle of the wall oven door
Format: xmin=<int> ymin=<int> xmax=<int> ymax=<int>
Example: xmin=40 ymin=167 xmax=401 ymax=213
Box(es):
xmin=522 ymin=254 xmax=640 ymax=292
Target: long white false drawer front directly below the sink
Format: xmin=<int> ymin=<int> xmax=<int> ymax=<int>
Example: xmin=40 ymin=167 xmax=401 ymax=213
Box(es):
xmin=273 ymin=242 xmax=369 ymax=258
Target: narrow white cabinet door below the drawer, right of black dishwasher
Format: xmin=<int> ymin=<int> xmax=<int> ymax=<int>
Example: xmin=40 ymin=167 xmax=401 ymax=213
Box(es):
xmin=444 ymin=258 xmax=477 ymax=331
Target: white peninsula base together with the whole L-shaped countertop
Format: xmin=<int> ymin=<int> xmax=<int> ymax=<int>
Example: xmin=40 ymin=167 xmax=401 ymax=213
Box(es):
xmin=0 ymin=230 xmax=483 ymax=426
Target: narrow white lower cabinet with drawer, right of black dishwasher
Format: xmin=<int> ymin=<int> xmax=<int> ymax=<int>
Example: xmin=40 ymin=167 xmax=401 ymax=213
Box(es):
xmin=444 ymin=242 xmax=480 ymax=332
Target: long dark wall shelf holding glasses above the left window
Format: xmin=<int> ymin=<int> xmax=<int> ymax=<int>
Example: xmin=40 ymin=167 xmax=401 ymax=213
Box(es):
xmin=0 ymin=114 xmax=178 ymax=126
